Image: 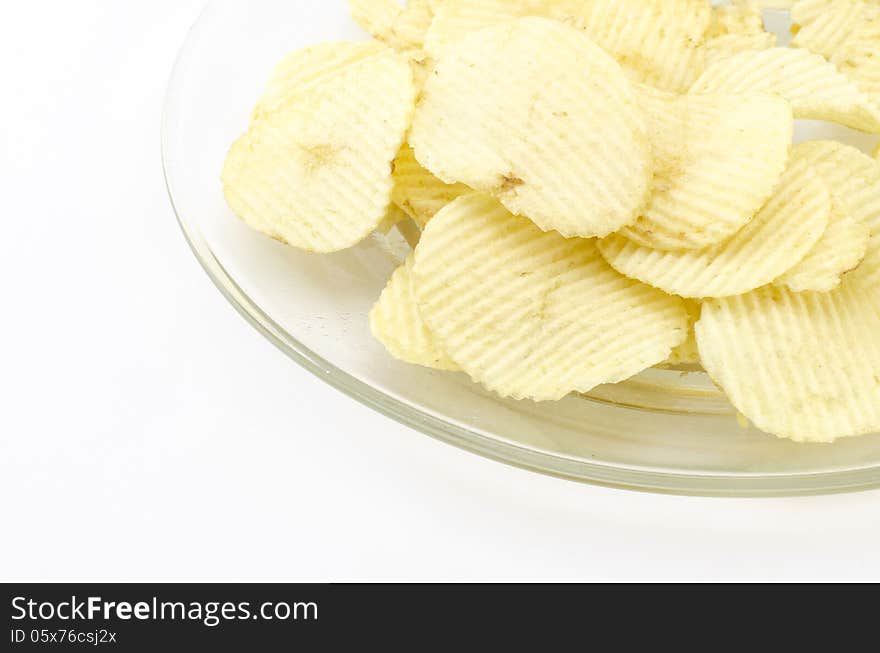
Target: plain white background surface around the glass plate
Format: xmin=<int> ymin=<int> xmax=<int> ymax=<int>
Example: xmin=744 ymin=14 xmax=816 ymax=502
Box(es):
xmin=0 ymin=0 xmax=880 ymax=581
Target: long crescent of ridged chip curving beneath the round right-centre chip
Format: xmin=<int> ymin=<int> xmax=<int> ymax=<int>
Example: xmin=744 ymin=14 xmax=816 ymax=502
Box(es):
xmin=599 ymin=161 xmax=831 ymax=299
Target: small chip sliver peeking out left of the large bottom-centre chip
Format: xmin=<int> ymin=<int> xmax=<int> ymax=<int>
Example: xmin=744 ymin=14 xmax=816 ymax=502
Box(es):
xmin=370 ymin=255 xmax=458 ymax=371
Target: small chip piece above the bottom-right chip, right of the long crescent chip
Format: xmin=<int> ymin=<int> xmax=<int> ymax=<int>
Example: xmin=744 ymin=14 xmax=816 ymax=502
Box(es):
xmin=776 ymin=197 xmax=871 ymax=292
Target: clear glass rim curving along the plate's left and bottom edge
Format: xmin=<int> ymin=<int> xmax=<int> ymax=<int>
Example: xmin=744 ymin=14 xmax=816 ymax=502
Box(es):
xmin=161 ymin=2 xmax=880 ymax=497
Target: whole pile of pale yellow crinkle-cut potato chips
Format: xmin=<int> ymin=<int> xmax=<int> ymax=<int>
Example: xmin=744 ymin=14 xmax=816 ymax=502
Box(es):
xmin=223 ymin=0 xmax=880 ymax=442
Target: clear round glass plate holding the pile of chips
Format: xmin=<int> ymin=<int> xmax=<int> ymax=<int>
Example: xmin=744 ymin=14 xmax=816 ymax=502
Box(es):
xmin=163 ymin=0 xmax=880 ymax=495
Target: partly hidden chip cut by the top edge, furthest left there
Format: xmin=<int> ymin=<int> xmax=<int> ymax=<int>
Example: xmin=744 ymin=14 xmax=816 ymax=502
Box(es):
xmin=348 ymin=0 xmax=434 ymax=51
